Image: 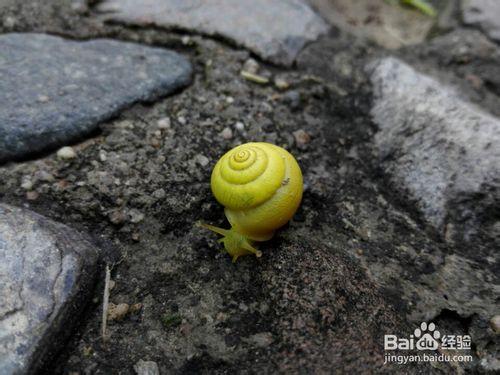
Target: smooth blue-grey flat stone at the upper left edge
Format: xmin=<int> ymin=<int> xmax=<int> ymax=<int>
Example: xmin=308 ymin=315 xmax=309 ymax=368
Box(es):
xmin=0 ymin=33 xmax=192 ymax=163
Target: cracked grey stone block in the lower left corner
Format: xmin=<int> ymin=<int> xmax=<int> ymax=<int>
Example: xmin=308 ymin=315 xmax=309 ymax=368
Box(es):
xmin=0 ymin=203 xmax=98 ymax=375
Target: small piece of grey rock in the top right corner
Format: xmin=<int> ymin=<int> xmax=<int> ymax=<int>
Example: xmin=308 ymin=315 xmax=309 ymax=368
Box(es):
xmin=462 ymin=0 xmax=500 ymax=42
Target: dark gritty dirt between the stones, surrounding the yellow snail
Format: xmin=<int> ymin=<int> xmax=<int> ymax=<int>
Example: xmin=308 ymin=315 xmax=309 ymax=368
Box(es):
xmin=0 ymin=0 xmax=500 ymax=374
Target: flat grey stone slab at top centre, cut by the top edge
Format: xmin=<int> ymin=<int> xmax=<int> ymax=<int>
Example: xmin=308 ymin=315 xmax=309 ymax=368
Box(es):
xmin=98 ymin=0 xmax=328 ymax=66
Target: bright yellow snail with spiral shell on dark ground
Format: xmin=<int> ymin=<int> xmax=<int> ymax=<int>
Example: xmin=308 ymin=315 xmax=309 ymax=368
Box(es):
xmin=201 ymin=142 xmax=303 ymax=263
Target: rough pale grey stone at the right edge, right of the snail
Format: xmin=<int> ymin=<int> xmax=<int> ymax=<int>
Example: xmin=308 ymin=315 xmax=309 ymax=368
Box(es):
xmin=368 ymin=58 xmax=500 ymax=238
